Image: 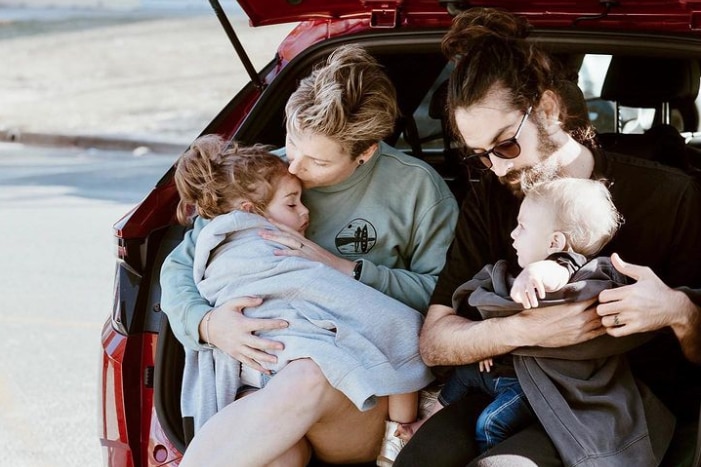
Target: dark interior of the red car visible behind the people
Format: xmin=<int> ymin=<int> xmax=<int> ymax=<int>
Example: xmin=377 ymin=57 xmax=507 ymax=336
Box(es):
xmin=145 ymin=31 xmax=701 ymax=466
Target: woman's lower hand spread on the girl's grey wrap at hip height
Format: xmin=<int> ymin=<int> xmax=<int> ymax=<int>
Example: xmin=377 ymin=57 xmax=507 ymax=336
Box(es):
xmin=199 ymin=297 xmax=288 ymax=374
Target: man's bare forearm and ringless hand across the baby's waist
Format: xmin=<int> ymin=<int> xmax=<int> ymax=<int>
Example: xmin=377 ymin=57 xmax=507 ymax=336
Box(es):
xmin=420 ymin=300 xmax=606 ymax=366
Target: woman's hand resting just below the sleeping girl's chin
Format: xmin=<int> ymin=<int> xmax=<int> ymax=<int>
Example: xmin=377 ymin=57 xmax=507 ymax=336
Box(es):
xmin=259 ymin=219 xmax=355 ymax=275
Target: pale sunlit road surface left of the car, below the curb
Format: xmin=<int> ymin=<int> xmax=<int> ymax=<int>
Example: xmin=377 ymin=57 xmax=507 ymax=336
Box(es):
xmin=0 ymin=143 xmax=175 ymax=467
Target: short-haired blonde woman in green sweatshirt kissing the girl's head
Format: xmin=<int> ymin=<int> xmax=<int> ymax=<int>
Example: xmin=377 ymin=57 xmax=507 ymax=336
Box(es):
xmin=161 ymin=46 xmax=457 ymax=467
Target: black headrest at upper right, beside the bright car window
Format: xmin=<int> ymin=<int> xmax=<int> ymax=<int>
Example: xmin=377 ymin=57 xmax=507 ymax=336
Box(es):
xmin=601 ymin=56 xmax=701 ymax=107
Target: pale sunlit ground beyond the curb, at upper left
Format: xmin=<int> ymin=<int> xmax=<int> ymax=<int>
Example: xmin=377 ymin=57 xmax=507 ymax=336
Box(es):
xmin=0 ymin=4 xmax=292 ymax=152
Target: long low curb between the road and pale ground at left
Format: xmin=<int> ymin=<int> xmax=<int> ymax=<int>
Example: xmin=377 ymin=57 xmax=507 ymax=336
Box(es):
xmin=0 ymin=130 xmax=188 ymax=154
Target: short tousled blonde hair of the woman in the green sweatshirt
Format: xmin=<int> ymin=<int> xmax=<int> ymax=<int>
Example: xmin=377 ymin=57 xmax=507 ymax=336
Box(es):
xmin=285 ymin=45 xmax=399 ymax=159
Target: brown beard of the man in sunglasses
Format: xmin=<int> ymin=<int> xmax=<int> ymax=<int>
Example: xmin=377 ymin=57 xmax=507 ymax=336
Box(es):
xmin=499 ymin=121 xmax=563 ymax=198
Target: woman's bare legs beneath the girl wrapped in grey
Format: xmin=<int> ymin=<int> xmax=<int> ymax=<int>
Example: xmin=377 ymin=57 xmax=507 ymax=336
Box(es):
xmin=180 ymin=359 xmax=387 ymax=467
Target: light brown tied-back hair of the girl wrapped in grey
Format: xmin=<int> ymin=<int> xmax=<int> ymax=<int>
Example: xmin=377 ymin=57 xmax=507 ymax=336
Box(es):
xmin=174 ymin=135 xmax=291 ymax=225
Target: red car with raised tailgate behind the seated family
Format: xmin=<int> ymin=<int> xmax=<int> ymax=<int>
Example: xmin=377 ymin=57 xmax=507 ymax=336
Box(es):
xmin=99 ymin=0 xmax=701 ymax=467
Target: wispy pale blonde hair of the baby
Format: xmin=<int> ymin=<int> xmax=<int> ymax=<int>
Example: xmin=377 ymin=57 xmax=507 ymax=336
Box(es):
xmin=525 ymin=178 xmax=623 ymax=257
